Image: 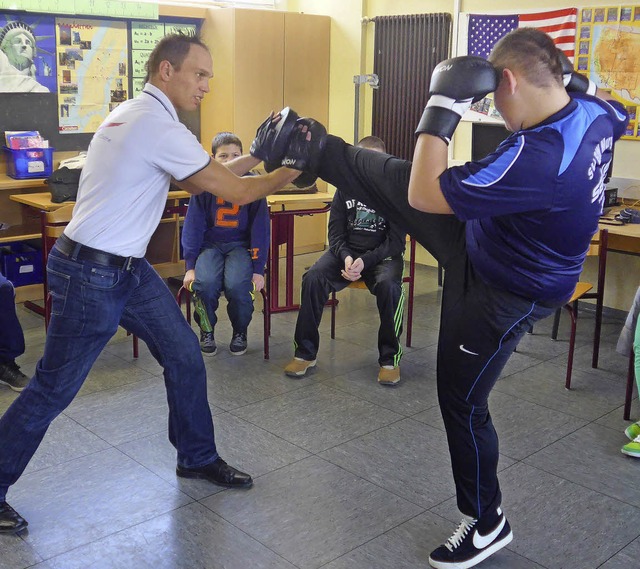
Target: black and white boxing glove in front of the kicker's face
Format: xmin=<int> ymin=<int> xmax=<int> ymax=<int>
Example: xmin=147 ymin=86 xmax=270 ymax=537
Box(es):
xmin=416 ymin=55 xmax=499 ymax=144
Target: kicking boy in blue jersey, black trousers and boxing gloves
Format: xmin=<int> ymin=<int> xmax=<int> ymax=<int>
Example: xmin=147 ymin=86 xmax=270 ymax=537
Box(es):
xmin=253 ymin=28 xmax=628 ymax=569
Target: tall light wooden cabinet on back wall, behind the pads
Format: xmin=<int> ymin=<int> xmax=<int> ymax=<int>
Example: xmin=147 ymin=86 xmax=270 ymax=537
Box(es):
xmin=200 ymin=8 xmax=331 ymax=253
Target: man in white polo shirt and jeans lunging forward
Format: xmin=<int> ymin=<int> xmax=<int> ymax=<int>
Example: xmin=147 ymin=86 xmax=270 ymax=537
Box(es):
xmin=0 ymin=35 xmax=299 ymax=532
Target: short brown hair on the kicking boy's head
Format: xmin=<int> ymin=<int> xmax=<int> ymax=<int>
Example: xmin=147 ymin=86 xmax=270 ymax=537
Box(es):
xmin=489 ymin=28 xmax=562 ymax=87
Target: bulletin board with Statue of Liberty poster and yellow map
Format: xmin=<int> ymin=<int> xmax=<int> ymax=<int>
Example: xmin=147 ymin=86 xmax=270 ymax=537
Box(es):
xmin=0 ymin=11 xmax=200 ymax=150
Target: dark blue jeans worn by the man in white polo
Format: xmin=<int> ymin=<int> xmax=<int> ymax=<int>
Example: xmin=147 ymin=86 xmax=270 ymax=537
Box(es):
xmin=0 ymin=242 xmax=218 ymax=501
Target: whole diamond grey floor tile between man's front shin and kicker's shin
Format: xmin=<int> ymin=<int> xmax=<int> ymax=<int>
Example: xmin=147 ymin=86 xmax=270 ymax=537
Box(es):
xmin=233 ymin=385 xmax=401 ymax=453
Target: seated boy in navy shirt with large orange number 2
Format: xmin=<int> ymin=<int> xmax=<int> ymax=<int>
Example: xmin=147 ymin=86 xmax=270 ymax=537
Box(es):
xmin=182 ymin=132 xmax=269 ymax=356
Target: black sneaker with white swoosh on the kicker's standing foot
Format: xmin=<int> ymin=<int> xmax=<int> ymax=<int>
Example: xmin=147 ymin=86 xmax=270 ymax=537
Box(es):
xmin=429 ymin=508 xmax=513 ymax=569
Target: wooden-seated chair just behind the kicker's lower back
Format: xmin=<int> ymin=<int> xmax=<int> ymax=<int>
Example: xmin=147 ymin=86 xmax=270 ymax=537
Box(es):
xmin=551 ymin=229 xmax=609 ymax=389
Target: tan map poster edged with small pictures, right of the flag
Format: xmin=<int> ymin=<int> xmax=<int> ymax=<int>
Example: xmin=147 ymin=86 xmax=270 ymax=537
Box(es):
xmin=575 ymin=5 xmax=640 ymax=140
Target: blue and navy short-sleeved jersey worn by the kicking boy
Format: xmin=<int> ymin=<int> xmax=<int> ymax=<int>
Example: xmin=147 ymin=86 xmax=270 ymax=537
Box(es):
xmin=440 ymin=94 xmax=628 ymax=302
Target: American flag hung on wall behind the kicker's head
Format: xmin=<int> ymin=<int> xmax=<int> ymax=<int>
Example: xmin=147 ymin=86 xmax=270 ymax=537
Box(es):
xmin=467 ymin=8 xmax=578 ymax=60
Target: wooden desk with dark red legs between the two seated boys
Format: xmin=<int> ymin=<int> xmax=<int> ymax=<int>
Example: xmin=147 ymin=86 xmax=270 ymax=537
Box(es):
xmin=267 ymin=192 xmax=333 ymax=313
